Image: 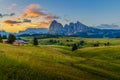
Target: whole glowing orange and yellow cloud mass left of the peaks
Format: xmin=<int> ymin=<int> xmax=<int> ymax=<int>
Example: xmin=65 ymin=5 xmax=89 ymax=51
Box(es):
xmin=0 ymin=4 xmax=59 ymax=32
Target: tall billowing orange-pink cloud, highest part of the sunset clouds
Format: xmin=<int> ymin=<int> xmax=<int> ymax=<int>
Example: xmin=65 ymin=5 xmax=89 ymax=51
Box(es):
xmin=22 ymin=4 xmax=60 ymax=21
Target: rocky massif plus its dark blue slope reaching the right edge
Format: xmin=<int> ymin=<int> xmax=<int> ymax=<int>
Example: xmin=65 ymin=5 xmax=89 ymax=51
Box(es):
xmin=49 ymin=21 xmax=120 ymax=38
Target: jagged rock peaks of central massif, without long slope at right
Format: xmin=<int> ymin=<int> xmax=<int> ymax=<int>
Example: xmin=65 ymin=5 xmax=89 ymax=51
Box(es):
xmin=49 ymin=21 xmax=98 ymax=35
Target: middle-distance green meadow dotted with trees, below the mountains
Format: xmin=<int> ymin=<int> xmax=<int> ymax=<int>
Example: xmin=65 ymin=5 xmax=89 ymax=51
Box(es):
xmin=22 ymin=37 xmax=120 ymax=47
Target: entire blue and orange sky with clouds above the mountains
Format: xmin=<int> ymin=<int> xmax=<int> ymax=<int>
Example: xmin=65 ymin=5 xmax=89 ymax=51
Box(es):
xmin=0 ymin=0 xmax=120 ymax=32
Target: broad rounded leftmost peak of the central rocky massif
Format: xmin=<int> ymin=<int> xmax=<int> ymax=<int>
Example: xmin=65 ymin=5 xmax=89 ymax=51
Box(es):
xmin=49 ymin=20 xmax=64 ymax=35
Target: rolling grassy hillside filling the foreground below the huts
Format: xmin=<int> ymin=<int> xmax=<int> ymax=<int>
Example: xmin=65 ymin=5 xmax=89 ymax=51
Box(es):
xmin=0 ymin=44 xmax=120 ymax=80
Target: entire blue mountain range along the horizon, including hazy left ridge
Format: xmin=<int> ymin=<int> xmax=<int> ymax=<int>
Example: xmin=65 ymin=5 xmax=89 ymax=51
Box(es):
xmin=0 ymin=20 xmax=120 ymax=38
